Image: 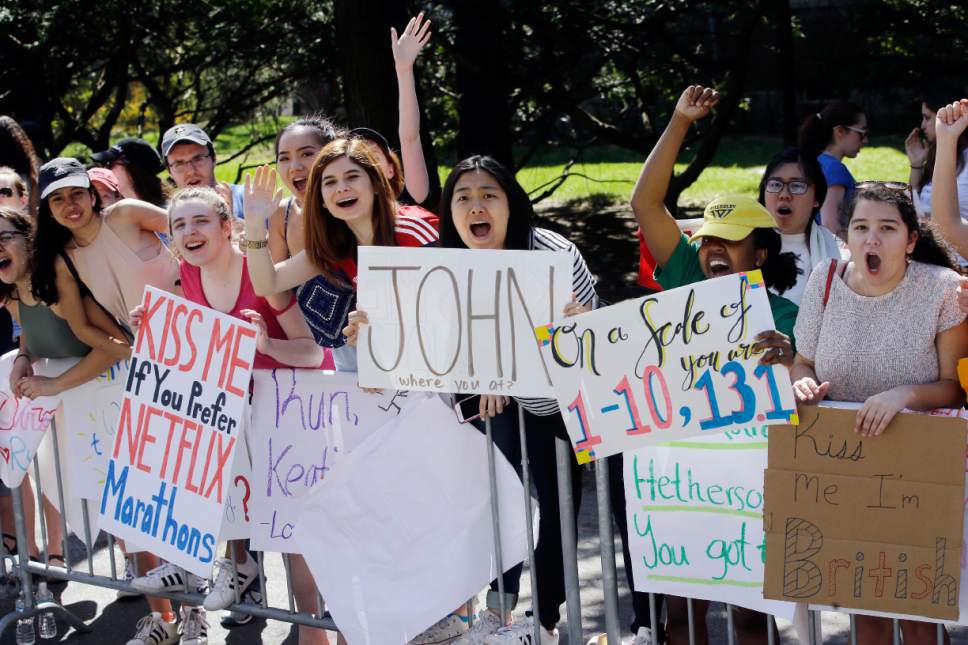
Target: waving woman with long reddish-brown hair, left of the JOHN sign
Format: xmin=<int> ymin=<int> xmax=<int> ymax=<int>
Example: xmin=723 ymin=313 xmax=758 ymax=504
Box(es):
xmin=242 ymin=139 xmax=437 ymax=372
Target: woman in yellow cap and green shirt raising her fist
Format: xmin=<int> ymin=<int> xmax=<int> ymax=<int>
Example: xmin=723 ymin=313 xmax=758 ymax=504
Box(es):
xmin=632 ymin=85 xmax=798 ymax=643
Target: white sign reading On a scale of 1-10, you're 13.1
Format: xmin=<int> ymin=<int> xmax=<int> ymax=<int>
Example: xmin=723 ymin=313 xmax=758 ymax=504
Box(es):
xmin=535 ymin=271 xmax=796 ymax=463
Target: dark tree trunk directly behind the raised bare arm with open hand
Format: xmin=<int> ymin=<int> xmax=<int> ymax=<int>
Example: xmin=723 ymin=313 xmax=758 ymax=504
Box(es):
xmin=333 ymin=0 xmax=440 ymax=204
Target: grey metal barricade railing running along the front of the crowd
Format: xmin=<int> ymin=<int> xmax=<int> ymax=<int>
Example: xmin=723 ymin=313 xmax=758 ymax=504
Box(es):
xmin=0 ymin=406 xmax=945 ymax=645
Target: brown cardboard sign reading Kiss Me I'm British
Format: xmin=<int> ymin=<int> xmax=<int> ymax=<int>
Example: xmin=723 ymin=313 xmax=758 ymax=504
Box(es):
xmin=764 ymin=406 xmax=966 ymax=620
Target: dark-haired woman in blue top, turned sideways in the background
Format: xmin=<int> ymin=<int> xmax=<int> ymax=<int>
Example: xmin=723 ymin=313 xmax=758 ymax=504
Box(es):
xmin=799 ymin=100 xmax=868 ymax=237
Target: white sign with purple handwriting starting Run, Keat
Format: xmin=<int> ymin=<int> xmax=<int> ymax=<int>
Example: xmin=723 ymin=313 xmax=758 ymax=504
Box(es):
xmin=249 ymin=369 xmax=418 ymax=553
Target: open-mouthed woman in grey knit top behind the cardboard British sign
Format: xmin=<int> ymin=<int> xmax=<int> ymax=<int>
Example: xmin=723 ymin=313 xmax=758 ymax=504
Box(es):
xmin=791 ymin=182 xmax=968 ymax=645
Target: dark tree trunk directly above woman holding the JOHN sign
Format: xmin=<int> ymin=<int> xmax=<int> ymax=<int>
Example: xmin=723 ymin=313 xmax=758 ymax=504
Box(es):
xmin=454 ymin=0 xmax=514 ymax=168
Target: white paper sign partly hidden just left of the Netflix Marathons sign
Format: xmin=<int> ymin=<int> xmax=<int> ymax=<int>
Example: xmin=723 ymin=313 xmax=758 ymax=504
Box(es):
xmin=61 ymin=361 xmax=129 ymax=501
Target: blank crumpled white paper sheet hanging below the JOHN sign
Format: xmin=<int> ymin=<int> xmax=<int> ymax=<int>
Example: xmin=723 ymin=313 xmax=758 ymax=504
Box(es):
xmin=295 ymin=396 xmax=527 ymax=645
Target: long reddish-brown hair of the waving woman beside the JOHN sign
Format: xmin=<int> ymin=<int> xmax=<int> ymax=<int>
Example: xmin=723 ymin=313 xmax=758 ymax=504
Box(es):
xmin=303 ymin=139 xmax=396 ymax=279
